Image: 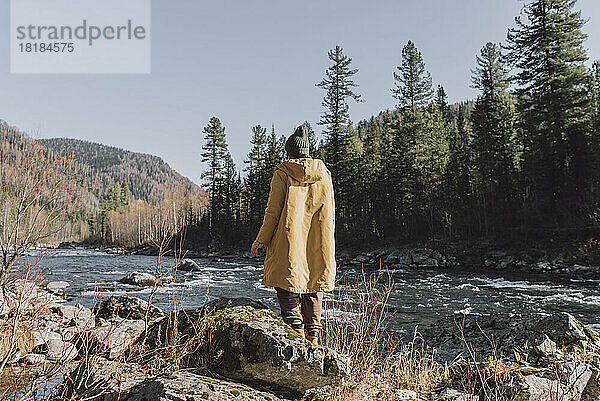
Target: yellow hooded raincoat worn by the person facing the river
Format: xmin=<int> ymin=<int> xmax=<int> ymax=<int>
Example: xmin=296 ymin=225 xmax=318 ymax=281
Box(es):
xmin=254 ymin=157 xmax=336 ymax=294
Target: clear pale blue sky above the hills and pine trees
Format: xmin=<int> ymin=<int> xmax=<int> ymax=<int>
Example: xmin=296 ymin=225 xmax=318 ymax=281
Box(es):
xmin=0 ymin=0 xmax=600 ymax=182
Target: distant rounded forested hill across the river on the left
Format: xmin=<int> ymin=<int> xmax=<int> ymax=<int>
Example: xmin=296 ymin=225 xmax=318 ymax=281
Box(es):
xmin=38 ymin=138 xmax=199 ymax=200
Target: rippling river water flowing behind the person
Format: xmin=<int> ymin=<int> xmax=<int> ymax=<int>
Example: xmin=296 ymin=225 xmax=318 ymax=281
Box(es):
xmin=21 ymin=249 xmax=600 ymax=329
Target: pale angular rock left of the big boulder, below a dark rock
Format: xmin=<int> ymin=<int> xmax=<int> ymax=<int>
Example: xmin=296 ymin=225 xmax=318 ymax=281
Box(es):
xmin=89 ymin=318 xmax=146 ymax=359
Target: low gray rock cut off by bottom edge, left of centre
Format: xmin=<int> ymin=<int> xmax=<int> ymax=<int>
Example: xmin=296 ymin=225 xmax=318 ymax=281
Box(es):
xmin=116 ymin=371 xmax=279 ymax=401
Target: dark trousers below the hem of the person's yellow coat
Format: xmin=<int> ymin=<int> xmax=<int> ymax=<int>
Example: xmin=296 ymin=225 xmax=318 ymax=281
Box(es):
xmin=276 ymin=288 xmax=323 ymax=337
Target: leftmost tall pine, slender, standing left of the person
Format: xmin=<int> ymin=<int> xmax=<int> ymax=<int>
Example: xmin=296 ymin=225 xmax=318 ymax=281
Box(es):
xmin=200 ymin=117 xmax=228 ymax=230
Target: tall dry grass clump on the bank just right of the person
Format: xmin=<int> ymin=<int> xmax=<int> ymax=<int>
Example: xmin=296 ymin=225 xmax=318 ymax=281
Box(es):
xmin=324 ymin=268 xmax=444 ymax=401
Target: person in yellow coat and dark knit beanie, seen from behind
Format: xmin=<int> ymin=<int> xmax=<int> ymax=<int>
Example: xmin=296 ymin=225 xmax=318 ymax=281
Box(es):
xmin=250 ymin=125 xmax=336 ymax=344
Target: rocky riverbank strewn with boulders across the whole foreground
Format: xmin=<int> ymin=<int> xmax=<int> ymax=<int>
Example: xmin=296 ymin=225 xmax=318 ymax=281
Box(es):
xmin=0 ymin=280 xmax=600 ymax=401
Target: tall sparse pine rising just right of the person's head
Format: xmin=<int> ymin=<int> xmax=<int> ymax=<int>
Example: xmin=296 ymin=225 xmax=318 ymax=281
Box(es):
xmin=316 ymin=46 xmax=361 ymax=185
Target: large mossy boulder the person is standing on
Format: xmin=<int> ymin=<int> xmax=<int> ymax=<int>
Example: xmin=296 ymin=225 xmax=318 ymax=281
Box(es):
xmin=203 ymin=300 xmax=349 ymax=396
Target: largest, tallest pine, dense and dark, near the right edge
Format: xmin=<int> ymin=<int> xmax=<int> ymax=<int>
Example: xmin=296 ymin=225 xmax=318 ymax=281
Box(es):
xmin=507 ymin=0 xmax=589 ymax=222
